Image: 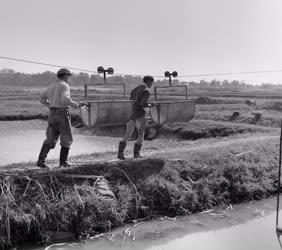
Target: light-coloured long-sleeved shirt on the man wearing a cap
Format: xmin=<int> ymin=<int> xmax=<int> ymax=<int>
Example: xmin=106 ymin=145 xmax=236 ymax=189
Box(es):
xmin=39 ymin=81 xmax=79 ymax=108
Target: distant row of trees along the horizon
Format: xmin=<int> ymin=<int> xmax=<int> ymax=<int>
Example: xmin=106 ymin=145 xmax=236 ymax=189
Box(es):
xmin=0 ymin=69 xmax=277 ymax=88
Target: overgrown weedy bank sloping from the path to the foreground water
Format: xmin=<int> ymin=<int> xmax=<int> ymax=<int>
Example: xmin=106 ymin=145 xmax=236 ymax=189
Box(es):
xmin=0 ymin=137 xmax=278 ymax=246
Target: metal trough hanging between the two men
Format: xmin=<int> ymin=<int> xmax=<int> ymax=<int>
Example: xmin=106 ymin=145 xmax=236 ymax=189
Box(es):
xmin=80 ymin=100 xmax=132 ymax=128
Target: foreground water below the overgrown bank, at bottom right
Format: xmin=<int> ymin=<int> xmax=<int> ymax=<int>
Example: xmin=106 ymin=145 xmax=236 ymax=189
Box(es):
xmin=25 ymin=198 xmax=280 ymax=250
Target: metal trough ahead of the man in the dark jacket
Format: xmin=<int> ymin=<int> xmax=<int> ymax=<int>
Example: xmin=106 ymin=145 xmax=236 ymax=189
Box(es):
xmin=151 ymin=100 xmax=195 ymax=124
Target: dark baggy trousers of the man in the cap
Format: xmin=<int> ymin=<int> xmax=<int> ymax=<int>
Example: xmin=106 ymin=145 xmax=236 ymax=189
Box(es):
xmin=44 ymin=108 xmax=73 ymax=148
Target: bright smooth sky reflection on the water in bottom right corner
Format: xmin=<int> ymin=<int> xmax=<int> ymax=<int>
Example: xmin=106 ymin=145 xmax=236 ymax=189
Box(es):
xmin=146 ymin=214 xmax=280 ymax=250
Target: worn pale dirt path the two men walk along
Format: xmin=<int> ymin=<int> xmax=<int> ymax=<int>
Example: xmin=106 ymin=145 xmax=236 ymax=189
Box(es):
xmin=0 ymin=133 xmax=279 ymax=172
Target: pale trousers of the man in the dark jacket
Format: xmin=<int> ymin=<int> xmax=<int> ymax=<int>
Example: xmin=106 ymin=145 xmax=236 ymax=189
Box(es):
xmin=121 ymin=117 xmax=146 ymax=145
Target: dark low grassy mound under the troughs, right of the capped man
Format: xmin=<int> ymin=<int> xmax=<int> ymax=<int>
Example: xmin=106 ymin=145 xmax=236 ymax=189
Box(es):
xmin=75 ymin=120 xmax=276 ymax=141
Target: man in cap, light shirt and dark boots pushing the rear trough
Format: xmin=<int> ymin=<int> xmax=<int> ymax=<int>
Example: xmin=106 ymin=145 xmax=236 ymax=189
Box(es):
xmin=37 ymin=69 xmax=83 ymax=168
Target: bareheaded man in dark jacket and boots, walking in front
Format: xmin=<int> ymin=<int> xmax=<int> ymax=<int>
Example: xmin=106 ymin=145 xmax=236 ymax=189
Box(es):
xmin=117 ymin=76 xmax=154 ymax=160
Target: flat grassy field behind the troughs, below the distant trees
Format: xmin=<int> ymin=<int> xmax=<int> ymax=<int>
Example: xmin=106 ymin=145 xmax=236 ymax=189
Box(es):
xmin=0 ymin=86 xmax=282 ymax=124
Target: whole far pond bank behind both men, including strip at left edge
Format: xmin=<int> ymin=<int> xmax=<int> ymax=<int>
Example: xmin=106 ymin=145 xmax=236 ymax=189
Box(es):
xmin=0 ymin=110 xmax=275 ymax=143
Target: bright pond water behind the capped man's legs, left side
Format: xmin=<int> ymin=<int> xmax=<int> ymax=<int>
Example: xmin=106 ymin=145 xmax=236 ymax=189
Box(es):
xmin=0 ymin=121 xmax=119 ymax=166
